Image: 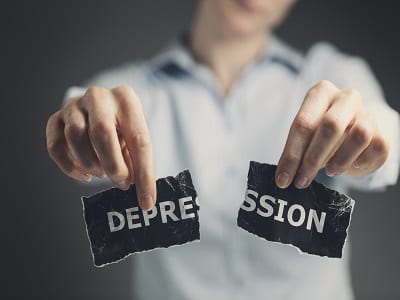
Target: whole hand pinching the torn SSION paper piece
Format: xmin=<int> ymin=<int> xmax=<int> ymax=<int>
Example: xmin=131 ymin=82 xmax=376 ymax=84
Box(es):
xmin=275 ymin=81 xmax=389 ymax=188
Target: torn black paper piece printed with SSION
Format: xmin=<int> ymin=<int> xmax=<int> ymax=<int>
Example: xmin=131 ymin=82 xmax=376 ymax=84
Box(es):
xmin=237 ymin=161 xmax=354 ymax=258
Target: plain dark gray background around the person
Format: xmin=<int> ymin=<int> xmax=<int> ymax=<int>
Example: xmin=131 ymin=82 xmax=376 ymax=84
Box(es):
xmin=0 ymin=0 xmax=400 ymax=300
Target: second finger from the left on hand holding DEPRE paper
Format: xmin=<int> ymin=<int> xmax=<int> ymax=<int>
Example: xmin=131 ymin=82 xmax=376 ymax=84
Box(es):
xmin=63 ymin=104 xmax=104 ymax=177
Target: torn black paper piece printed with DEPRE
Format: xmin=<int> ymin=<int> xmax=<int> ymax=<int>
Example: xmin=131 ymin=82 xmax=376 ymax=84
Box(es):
xmin=82 ymin=170 xmax=200 ymax=267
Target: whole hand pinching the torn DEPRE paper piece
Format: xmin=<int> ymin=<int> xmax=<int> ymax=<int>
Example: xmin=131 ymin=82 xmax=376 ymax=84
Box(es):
xmin=46 ymin=85 xmax=156 ymax=210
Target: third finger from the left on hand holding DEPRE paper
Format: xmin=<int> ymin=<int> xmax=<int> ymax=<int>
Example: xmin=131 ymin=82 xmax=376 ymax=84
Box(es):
xmin=83 ymin=88 xmax=130 ymax=190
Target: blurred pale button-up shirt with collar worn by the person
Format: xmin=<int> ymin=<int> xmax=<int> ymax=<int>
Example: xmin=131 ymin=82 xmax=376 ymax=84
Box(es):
xmin=66 ymin=37 xmax=400 ymax=300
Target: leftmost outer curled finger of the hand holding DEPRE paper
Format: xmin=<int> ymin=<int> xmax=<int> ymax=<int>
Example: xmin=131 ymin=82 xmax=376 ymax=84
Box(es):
xmin=46 ymin=112 xmax=91 ymax=182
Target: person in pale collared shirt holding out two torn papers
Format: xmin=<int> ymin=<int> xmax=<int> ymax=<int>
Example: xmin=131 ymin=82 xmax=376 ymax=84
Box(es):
xmin=46 ymin=0 xmax=399 ymax=299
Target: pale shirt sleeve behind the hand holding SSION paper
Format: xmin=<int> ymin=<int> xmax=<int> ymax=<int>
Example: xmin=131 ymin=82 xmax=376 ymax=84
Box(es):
xmin=306 ymin=43 xmax=400 ymax=190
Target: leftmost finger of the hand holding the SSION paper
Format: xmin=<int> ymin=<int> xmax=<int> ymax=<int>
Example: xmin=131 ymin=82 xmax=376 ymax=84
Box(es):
xmin=275 ymin=81 xmax=338 ymax=188
